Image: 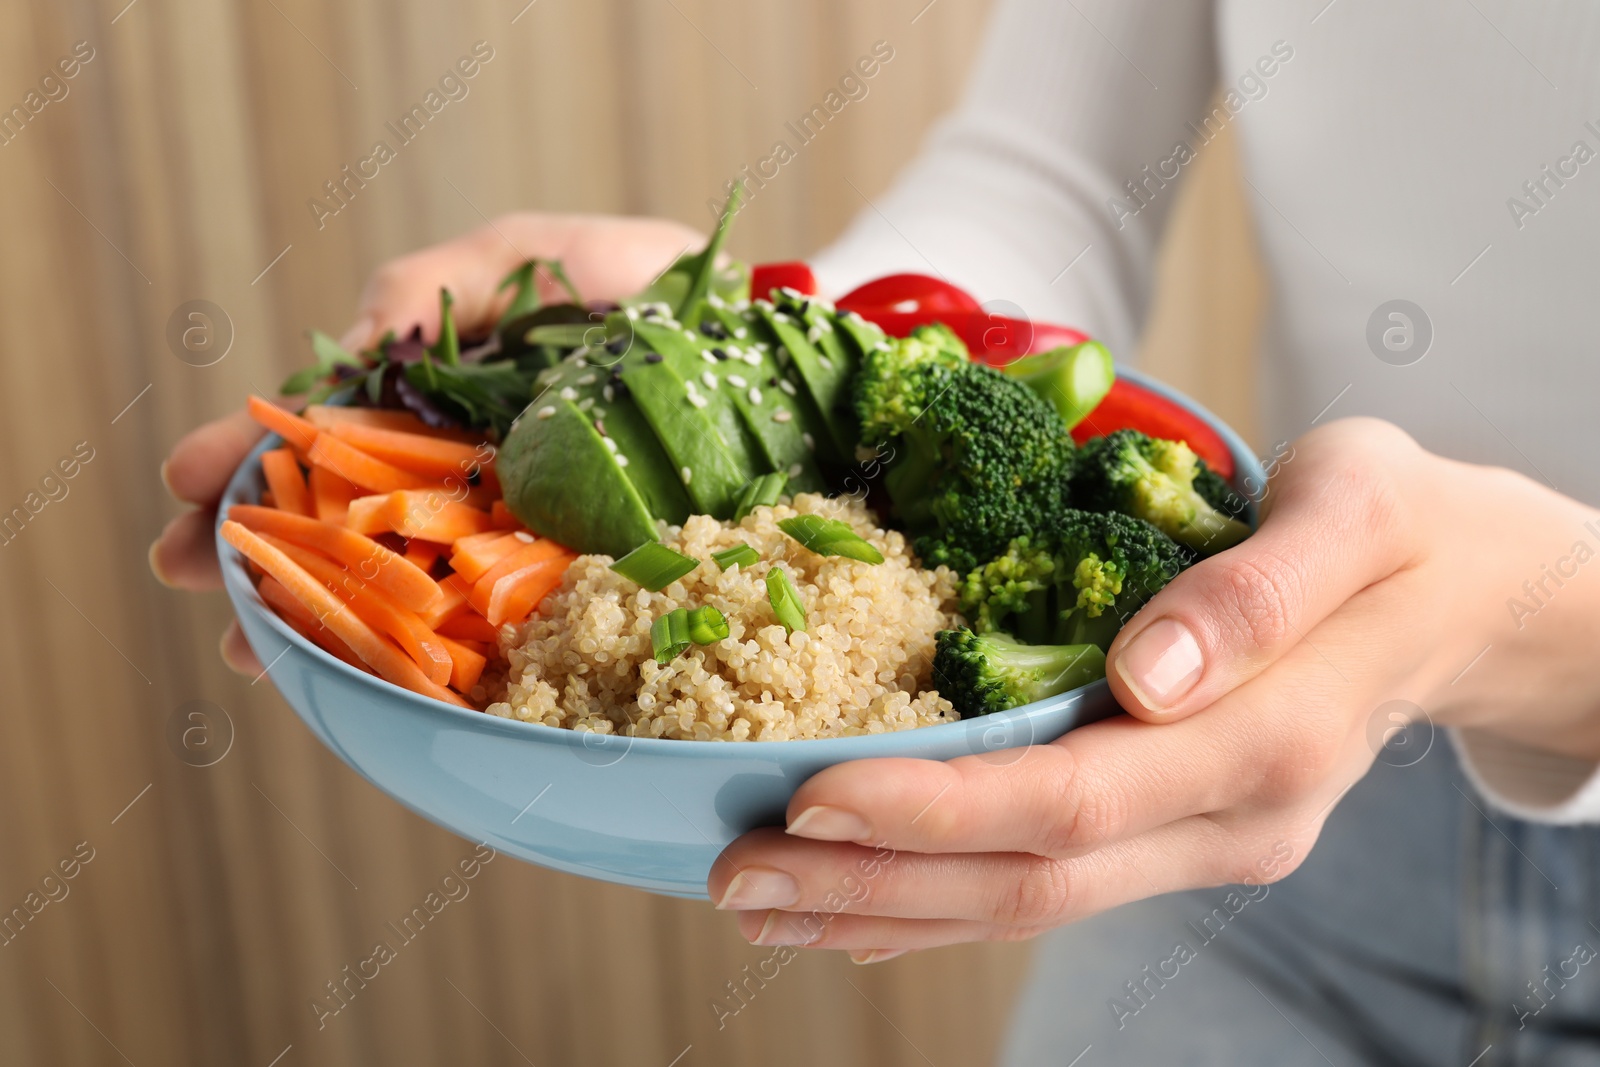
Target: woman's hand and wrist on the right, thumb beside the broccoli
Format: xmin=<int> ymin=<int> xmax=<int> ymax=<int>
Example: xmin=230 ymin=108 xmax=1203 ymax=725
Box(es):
xmin=709 ymin=419 xmax=1600 ymax=961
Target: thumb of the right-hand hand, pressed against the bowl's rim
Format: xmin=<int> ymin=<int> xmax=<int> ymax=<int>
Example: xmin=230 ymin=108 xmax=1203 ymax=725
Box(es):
xmin=1107 ymin=419 xmax=1424 ymax=723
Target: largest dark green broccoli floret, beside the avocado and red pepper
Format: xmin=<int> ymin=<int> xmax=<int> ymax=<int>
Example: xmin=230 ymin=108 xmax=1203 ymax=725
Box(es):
xmin=854 ymin=326 xmax=1074 ymax=573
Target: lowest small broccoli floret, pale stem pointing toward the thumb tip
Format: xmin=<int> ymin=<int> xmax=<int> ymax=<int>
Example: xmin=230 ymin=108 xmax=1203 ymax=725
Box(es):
xmin=933 ymin=629 xmax=1106 ymax=718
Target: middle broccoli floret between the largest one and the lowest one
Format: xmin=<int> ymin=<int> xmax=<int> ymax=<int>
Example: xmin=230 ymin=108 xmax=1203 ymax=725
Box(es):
xmin=962 ymin=509 xmax=1194 ymax=649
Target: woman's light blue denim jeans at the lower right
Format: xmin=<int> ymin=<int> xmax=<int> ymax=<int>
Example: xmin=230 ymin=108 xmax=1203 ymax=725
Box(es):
xmin=1002 ymin=734 xmax=1600 ymax=1067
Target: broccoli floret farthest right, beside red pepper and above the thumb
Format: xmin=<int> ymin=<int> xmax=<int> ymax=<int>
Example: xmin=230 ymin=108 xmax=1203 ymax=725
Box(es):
xmin=1072 ymin=430 xmax=1250 ymax=555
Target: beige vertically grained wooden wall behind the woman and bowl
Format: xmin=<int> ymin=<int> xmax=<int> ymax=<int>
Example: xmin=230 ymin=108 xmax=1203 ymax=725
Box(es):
xmin=0 ymin=0 xmax=1261 ymax=1067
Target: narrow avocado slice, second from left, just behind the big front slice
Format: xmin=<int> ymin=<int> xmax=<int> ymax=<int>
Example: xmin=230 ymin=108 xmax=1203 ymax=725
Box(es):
xmin=534 ymin=349 xmax=693 ymax=523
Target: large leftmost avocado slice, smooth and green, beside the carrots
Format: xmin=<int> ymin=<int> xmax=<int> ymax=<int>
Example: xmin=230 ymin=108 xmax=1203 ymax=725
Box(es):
xmin=494 ymin=397 xmax=656 ymax=557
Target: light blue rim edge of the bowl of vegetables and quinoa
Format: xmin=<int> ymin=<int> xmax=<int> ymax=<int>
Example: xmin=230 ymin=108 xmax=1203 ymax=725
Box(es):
xmin=213 ymin=365 xmax=1266 ymax=760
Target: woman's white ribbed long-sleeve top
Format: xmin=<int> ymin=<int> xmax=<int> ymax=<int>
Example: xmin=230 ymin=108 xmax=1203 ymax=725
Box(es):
xmin=814 ymin=0 xmax=1600 ymax=822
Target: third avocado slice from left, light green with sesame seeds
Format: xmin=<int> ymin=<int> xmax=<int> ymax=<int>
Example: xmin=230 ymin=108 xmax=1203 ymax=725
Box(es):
xmin=622 ymin=354 xmax=754 ymax=518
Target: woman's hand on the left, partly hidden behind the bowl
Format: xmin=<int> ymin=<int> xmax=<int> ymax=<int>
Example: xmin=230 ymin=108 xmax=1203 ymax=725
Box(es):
xmin=150 ymin=211 xmax=702 ymax=673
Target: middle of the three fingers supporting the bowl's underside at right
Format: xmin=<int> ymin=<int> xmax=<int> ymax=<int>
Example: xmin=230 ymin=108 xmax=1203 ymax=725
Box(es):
xmin=709 ymin=817 xmax=1248 ymax=927
